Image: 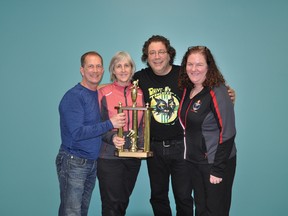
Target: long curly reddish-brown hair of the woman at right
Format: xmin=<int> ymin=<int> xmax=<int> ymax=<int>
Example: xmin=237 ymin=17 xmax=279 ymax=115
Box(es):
xmin=178 ymin=46 xmax=226 ymax=90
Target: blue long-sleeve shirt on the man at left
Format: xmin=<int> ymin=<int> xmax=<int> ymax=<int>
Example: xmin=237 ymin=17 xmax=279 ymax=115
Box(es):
xmin=59 ymin=83 xmax=113 ymax=160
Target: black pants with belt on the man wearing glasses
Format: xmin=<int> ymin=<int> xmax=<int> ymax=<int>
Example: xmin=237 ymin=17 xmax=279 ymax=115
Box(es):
xmin=147 ymin=140 xmax=193 ymax=216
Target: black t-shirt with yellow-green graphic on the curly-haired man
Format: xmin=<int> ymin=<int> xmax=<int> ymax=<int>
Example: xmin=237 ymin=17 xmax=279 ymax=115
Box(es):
xmin=133 ymin=65 xmax=183 ymax=140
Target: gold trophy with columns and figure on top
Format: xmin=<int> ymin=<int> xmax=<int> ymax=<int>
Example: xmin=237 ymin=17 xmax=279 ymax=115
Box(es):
xmin=115 ymin=80 xmax=153 ymax=158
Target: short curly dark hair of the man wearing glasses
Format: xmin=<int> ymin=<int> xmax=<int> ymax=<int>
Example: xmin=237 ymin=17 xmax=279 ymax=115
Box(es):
xmin=141 ymin=35 xmax=176 ymax=66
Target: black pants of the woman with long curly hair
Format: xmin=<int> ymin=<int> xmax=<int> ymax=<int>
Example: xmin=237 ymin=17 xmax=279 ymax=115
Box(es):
xmin=189 ymin=157 xmax=236 ymax=216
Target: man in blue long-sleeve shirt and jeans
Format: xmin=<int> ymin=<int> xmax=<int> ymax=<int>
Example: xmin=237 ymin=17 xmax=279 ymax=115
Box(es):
xmin=56 ymin=51 xmax=125 ymax=216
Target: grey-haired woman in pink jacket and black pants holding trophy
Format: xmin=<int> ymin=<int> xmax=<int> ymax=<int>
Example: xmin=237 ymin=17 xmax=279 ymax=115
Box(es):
xmin=97 ymin=51 xmax=144 ymax=216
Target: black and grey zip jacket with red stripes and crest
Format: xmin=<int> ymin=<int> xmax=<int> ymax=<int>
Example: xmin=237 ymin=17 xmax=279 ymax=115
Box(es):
xmin=178 ymin=85 xmax=236 ymax=177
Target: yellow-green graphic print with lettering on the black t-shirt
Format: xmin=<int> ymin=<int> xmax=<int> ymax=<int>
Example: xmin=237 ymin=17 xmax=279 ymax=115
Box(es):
xmin=149 ymin=87 xmax=179 ymax=124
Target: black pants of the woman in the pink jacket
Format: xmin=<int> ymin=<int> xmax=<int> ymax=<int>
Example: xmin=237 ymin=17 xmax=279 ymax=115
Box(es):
xmin=97 ymin=158 xmax=141 ymax=216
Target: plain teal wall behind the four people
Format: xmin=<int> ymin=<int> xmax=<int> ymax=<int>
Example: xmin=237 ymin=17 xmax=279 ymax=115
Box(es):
xmin=0 ymin=0 xmax=288 ymax=216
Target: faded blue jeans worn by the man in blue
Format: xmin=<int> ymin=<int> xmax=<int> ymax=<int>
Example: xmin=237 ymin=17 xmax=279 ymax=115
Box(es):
xmin=56 ymin=150 xmax=97 ymax=216
